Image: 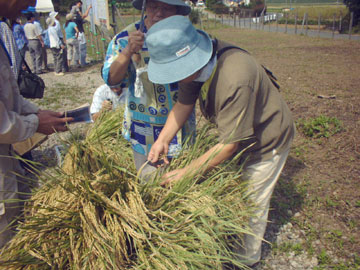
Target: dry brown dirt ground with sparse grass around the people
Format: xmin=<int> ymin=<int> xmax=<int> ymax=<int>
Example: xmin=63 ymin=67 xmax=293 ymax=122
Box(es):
xmin=32 ymin=28 xmax=360 ymax=269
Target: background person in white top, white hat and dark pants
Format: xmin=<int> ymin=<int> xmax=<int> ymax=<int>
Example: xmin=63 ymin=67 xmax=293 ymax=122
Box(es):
xmin=46 ymin=17 xmax=65 ymax=76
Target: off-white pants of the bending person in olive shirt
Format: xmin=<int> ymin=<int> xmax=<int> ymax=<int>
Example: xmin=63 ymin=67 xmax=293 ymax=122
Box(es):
xmin=235 ymin=149 xmax=290 ymax=266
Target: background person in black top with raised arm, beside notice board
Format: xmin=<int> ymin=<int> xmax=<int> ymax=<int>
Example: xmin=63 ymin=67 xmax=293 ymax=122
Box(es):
xmin=70 ymin=1 xmax=92 ymax=66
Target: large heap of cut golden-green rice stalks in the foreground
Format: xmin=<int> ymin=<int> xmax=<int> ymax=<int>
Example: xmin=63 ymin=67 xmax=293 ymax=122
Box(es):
xmin=0 ymin=108 xmax=252 ymax=269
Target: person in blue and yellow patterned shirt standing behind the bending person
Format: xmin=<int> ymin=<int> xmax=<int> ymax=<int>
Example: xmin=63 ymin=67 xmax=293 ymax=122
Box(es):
xmin=102 ymin=0 xmax=195 ymax=178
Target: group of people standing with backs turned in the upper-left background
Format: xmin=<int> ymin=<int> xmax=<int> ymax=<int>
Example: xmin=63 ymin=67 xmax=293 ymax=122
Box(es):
xmin=5 ymin=1 xmax=92 ymax=76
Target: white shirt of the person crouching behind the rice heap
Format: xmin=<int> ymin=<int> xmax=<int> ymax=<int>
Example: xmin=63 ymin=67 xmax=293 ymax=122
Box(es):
xmin=90 ymin=84 xmax=126 ymax=114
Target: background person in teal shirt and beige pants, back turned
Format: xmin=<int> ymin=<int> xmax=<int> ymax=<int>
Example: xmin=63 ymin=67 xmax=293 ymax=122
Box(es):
xmin=64 ymin=13 xmax=80 ymax=67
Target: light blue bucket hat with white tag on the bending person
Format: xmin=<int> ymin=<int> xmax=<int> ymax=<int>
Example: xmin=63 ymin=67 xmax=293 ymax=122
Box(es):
xmin=145 ymin=16 xmax=213 ymax=84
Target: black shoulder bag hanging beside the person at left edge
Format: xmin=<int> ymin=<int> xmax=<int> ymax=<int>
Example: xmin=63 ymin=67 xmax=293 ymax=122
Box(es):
xmin=18 ymin=59 xmax=45 ymax=98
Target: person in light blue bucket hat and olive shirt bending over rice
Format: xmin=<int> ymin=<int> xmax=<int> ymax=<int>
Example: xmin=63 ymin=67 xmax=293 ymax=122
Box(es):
xmin=145 ymin=16 xmax=295 ymax=266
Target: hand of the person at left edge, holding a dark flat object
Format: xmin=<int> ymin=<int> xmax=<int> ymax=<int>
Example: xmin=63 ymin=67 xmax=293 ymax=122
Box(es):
xmin=37 ymin=110 xmax=74 ymax=135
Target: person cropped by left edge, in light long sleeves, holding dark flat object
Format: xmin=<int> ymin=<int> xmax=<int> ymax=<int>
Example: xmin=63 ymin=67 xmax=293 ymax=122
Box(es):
xmin=0 ymin=0 xmax=73 ymax=248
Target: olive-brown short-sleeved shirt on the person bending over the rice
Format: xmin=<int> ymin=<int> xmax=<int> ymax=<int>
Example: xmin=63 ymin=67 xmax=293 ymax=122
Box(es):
xmin=178 ymin=41 xmax=295 ymax=162
